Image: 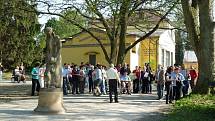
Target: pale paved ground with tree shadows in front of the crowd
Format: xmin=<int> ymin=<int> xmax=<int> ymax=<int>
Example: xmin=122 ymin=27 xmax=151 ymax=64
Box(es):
xmin=0 ymin=80 xmax=170 ymax=121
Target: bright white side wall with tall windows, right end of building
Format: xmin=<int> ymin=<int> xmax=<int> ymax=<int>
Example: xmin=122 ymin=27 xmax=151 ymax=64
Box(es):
xmin=158 ymin=30 xmax=175 ymax=68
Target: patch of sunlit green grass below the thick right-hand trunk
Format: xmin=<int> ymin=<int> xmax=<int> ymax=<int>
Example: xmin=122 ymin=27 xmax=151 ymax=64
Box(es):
xmin=164 ymin=95 xmax=215 ymax=121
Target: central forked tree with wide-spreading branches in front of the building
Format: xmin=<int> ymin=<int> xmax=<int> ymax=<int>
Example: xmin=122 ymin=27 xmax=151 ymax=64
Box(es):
xmin=32 ymin=0 xmax=178 ymax=64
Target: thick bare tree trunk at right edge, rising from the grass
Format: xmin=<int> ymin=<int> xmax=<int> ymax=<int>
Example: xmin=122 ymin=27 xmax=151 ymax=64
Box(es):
xmin=181 ymin=0 xmax=215 ymax=94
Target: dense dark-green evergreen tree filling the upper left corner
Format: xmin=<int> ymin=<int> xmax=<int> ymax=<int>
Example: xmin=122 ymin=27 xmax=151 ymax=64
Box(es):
xmin=0 ymin=0 xmax=41 ymax=68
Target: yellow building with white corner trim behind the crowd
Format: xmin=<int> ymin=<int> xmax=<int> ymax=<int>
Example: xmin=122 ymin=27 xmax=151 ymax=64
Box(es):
xmin=62 ymin=29 xmax=174 ymax=70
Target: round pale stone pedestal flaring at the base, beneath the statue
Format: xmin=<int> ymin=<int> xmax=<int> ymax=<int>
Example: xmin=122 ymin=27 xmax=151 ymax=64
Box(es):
xmin=34 ymin=88 xmax=66 ymax=114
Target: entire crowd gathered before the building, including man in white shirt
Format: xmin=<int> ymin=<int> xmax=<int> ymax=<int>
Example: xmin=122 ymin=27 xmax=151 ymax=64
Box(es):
xmin=29 ymin=62 xmax=197 ymax=103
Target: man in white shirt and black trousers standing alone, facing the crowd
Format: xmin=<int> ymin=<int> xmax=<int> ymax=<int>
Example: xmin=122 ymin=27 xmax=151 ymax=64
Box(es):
xmin=106 ymin=64 xmax=120 ymax=103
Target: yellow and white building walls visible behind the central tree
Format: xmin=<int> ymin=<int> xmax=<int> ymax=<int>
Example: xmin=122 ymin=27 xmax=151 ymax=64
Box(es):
xmin=62 ymin=30 xmax=175 ymax=71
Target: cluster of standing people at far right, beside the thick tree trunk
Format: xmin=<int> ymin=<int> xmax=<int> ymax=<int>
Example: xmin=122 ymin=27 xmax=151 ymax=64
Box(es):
xmin=156 ymin=65 xmax=198 ymax=104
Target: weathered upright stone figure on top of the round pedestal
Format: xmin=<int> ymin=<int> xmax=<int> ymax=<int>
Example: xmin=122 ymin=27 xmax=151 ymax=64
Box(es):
xmin=45 ymin=27 xmax=63 ymax=88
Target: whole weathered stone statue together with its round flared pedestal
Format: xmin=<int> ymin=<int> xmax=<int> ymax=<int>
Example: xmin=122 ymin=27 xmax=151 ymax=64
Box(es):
xmin=34 ymin=27 xmax=66 ymax=114
